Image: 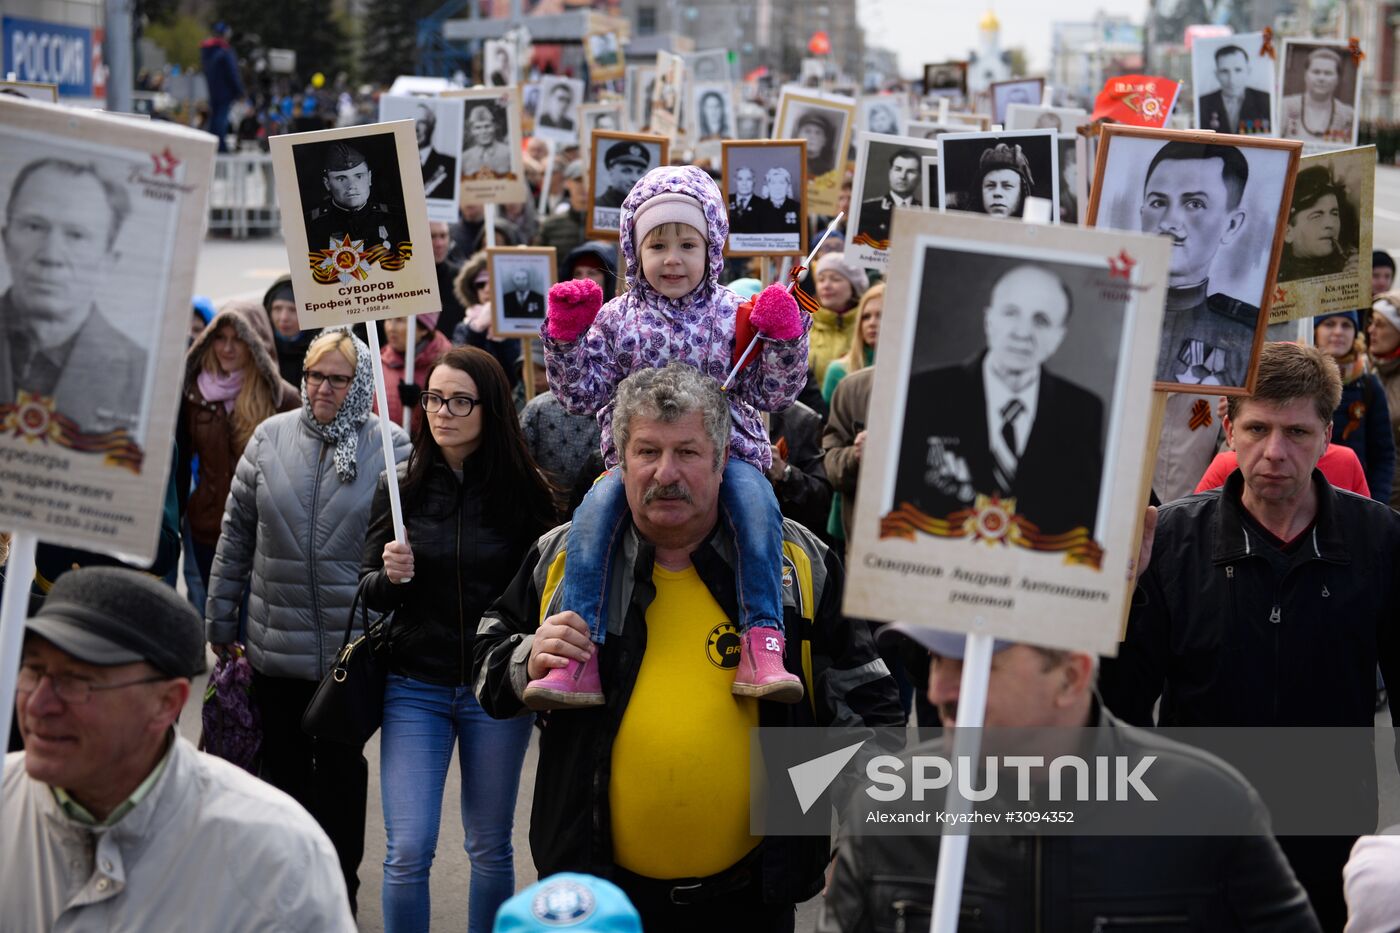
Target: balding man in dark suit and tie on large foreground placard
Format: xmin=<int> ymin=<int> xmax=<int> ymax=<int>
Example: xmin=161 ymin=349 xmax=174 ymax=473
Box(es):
xmin=893 ymin=262 xmax=1105 ymax=535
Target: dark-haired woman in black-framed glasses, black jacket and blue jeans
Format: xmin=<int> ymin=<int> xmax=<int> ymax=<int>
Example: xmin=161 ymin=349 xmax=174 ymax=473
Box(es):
xmin=361 ymin=347 xmax=554 ymax=933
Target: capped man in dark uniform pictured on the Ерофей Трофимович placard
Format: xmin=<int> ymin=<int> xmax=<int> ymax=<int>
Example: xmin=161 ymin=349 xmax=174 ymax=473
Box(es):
xmin=307 ymin=141 xmax=409 ymax=249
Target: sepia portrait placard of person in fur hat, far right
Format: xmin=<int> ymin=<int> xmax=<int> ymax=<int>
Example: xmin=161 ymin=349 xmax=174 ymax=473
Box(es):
xmin=1268 ymin=146 xmax=1376 ymax=324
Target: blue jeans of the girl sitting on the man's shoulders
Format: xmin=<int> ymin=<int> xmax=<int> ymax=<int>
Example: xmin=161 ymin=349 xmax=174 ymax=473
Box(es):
xmin=563 ymin=457 xmax=783 ymax=644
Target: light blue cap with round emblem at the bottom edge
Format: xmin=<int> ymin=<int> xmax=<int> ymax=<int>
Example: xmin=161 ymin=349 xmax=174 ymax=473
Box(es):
xmin=491 ymin=871 xmax=641 ymax=933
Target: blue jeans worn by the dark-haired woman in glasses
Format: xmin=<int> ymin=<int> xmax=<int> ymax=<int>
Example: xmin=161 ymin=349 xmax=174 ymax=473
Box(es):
xmin=379 ymin=674 xmax=533 ymax=933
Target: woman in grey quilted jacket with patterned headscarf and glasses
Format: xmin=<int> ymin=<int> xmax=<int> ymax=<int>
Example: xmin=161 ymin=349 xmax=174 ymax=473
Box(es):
xmin=206 ymin=329 xmax=409 ymax=909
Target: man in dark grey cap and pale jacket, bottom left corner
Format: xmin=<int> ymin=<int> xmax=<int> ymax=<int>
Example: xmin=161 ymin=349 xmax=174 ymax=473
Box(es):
xmin=0 ymin=567 xmax=354 ymax=933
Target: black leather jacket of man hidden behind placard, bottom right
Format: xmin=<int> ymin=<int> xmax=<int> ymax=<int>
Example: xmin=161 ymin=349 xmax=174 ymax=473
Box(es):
xmin=818 ymin=707 xmax=1319 ymax=933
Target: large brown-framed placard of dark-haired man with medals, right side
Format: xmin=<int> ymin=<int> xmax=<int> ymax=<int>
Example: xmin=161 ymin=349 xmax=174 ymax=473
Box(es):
xmin=1084 ymin=123 xmax=1302 ymax=395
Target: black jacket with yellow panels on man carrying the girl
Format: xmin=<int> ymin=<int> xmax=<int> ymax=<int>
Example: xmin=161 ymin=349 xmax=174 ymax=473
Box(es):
xmin=472 ymin=521 xmax=904 ymax=904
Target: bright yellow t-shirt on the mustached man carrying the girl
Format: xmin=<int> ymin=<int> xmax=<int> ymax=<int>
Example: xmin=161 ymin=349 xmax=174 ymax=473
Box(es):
xmin=609 ymin=566 xmax=759 ymax=878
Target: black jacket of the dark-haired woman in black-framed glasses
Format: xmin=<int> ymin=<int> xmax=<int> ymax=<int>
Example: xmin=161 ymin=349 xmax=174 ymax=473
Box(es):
xmin=360 ymin=459 xmax=546 ymax=686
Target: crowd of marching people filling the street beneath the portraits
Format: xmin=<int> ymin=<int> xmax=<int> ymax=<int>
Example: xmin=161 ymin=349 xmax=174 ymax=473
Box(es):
xmin=8 ymin=48 xmax=1400 ymax=933
